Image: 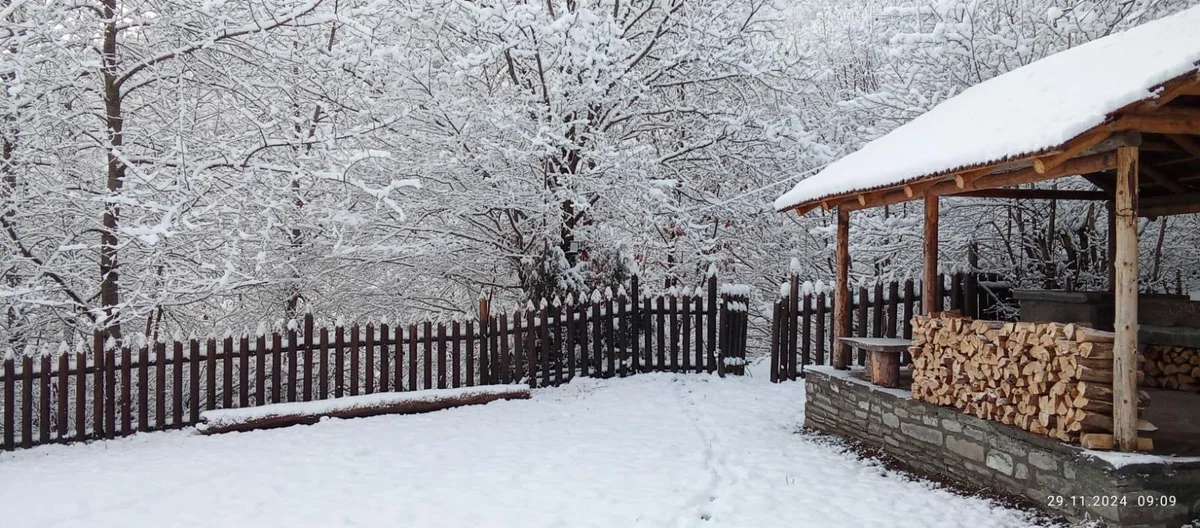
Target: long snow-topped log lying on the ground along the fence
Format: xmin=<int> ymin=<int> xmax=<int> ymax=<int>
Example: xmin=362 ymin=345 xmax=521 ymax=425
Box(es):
xmin=196 ymin=385 xmax=529 ymax=434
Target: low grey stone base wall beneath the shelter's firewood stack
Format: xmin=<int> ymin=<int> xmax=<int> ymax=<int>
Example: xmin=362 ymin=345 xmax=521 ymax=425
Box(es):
xmin=805 ymin=367 xmax=1200 ymax=528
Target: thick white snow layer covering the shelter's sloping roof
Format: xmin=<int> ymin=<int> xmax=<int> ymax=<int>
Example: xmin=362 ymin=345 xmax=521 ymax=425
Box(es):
xmin=775 ymin=6 xmax=1200 ymax=210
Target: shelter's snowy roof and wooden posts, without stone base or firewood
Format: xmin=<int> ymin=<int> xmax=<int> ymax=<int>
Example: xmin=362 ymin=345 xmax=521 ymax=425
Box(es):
xmin=775 ymin=7 xmax=1200 ymax=451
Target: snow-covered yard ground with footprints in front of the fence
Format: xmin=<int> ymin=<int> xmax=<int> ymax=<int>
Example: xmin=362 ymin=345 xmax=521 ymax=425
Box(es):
xmin=0 ymin=365 xmax=1051 ymax=528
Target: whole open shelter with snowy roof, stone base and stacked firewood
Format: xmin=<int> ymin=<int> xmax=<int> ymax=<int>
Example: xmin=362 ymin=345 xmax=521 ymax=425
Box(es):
xmin=775 ymin=7 xmax=1200 ymax=526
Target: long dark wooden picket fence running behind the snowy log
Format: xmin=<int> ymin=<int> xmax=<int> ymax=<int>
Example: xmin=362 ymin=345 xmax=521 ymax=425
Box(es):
xmin=0 ymin=277 xmax=748 ymax=450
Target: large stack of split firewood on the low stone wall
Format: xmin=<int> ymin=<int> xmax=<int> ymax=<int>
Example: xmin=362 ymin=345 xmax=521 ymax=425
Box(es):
xmin=910 ymin=312 xmax=1148 ymax=446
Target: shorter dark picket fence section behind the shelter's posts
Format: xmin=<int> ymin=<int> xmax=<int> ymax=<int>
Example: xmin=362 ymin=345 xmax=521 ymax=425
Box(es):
xmin=770 ymin=272 xmax=1012 ymax=382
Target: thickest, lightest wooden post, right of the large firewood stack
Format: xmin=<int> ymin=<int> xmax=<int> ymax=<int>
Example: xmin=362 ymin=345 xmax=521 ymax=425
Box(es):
xmin=1112 ymin=146 xmax=1138 ymax=452
